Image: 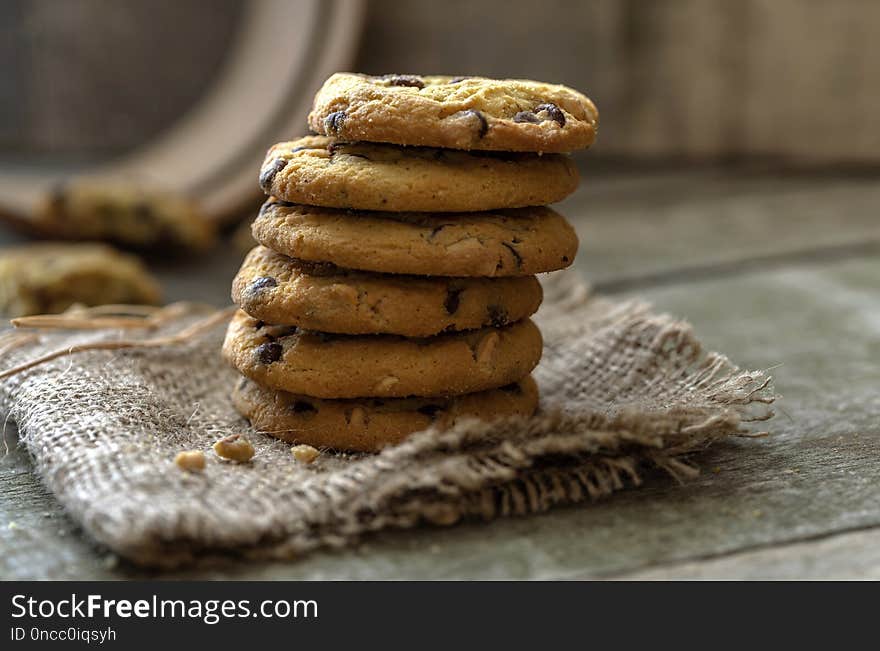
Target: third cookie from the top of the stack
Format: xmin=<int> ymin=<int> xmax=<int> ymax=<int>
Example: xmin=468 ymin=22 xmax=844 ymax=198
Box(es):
xmin=252 ymin=198 xmax=578 ymax=277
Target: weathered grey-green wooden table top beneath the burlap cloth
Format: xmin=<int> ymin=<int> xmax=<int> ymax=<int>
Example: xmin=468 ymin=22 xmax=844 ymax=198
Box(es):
xmin=0 ymin=169 xmax=880 ymax=579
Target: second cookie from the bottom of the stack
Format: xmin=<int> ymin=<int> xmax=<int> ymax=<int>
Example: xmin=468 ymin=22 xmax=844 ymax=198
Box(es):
xmin=223 ymin=310 xmax=542 ymax=398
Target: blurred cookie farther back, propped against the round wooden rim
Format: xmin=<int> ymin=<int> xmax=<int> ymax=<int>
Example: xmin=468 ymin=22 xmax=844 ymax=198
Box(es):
xmin=33 ymin=179 xmax=216 ymax=251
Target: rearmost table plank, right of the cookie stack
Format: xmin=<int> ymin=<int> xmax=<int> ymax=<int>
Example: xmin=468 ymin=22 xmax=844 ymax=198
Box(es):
xmin=559 ymin=171 xmax=880 ymax=286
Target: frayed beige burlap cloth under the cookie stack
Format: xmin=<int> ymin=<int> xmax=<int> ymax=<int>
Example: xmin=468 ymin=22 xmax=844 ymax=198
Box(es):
xmin=0 ymin=273 xmax=773 ymax=567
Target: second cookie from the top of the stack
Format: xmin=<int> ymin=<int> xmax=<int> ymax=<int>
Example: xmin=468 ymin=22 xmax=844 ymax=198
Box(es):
xmin=260 ymin=136 xmax=578 ymax=212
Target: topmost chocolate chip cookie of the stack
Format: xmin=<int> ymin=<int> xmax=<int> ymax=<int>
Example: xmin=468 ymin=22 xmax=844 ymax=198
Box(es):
xmin=309 ymin=73 xmax=599 ymax=153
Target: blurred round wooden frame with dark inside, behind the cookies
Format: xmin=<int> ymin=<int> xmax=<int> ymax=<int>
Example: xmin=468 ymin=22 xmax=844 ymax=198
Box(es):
xmin=0 ymin=0 xmax=363 ymax=220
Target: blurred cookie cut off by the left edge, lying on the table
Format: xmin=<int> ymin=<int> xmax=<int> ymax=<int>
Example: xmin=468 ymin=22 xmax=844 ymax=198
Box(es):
xmin=0 ymin=243 xmax=161 ymax=317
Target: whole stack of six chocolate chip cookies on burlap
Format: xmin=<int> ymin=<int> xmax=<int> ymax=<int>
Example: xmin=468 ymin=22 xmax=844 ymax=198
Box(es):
xmin=223 ymin=74 xmax=597 ymax=451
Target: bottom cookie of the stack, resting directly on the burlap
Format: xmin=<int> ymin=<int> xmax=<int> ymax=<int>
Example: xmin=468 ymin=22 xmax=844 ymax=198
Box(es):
xmin=232 ymin=377 xmax=538 ymax=452
